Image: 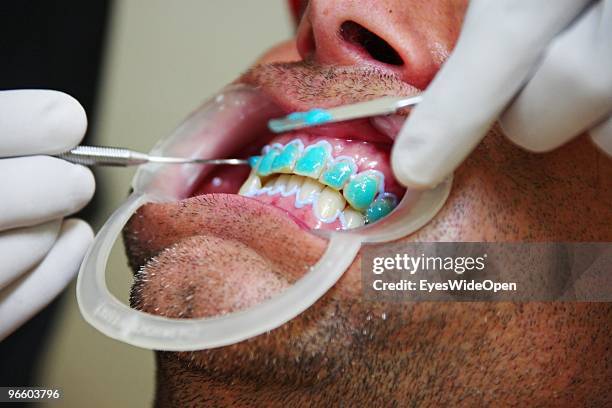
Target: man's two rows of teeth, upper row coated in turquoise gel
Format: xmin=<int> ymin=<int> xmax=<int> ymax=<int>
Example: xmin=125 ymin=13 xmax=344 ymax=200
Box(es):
xmin=239 ymin=139 xmax=397 ymax=229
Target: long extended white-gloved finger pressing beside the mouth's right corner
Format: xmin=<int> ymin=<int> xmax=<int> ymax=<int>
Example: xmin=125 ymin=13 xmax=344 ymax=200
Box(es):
xmin=391 ymin=0 xmax=588 ymax=188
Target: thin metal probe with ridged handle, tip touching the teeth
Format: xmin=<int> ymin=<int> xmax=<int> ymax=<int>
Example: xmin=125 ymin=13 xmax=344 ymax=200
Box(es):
xmin=55 ymin=146 xmax=249 ymax=167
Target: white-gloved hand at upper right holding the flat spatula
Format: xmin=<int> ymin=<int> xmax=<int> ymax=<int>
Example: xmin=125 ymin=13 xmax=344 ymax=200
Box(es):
xmin=392 ymin=0 xmax=612 ymax=188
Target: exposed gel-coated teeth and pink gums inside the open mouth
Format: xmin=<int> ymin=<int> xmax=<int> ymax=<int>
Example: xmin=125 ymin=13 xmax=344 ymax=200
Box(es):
xmin=193 ymin=132 xmax=405 ymax=230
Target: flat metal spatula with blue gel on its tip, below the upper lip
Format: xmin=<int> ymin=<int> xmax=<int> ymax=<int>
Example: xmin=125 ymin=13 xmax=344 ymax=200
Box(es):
xmin=268 ymin=94 xmax=422 ymax=133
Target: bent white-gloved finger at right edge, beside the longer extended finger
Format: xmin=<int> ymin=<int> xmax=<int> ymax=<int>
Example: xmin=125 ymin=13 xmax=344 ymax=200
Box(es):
xmin=500 ymin=0 xmax=612 ymax=152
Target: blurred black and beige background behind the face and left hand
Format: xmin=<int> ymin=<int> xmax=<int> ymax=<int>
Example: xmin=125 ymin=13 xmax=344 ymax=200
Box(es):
xmin=0 ymin=0 xmax=293 ymax=407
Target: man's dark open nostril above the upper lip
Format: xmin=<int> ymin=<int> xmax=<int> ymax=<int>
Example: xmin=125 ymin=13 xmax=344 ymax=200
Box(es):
xmin=340 ymin=21 xmax=404 ymax=65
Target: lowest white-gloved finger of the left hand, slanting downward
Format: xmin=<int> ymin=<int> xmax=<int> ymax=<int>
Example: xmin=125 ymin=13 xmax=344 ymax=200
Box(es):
xmin=0 ymin=219 xmax=93 ymax=340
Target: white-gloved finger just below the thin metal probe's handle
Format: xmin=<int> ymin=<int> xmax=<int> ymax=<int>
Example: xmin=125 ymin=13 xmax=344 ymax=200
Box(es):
xmin=0 ymin=156 xmax=95 ymax=231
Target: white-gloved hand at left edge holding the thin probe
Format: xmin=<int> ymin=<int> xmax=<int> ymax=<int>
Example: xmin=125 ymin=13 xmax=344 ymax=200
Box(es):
xmin=0 ymin=90 xmax=95 ymax=340
